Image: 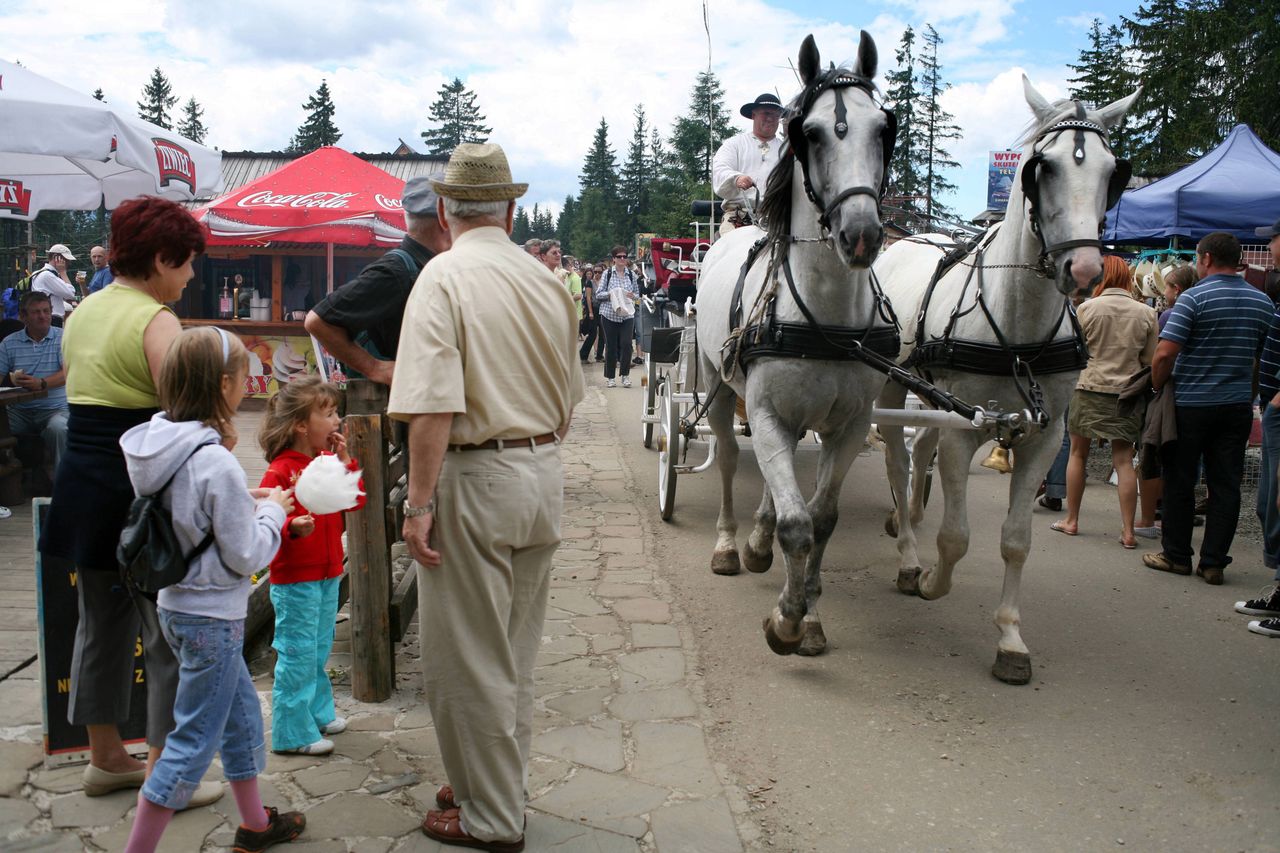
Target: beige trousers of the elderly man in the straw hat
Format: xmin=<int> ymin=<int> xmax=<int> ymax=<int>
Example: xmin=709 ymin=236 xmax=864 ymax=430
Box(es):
xmin=417 ymin=442 xmax=564 ymax=841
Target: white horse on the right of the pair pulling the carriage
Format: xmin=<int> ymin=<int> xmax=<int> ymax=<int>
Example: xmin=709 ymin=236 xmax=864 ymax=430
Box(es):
xmin=874 ymin=77 xmax=1138 ymax=684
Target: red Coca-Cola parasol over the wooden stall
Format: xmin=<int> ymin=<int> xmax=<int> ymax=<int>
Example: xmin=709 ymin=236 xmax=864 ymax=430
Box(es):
xmin=195 ymin=147 xmax=404 ymax=246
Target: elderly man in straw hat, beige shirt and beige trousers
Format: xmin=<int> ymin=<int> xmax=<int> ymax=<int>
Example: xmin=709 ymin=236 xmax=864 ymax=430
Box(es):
xmin=388 ymin=143 xmax=582 ymax=850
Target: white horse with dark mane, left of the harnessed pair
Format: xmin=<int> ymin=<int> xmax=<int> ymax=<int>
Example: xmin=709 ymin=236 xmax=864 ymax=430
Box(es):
xmin=698 ymin=32 xmax=897 ymax=654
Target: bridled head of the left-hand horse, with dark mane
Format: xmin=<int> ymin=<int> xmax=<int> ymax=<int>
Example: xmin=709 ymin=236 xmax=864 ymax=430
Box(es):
xmin=760 ymin=31 xmax=897 ymax=269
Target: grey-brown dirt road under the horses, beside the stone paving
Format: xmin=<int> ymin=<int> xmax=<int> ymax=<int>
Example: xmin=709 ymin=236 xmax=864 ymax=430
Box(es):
xmin=601 ymin=377 xmax=1280 ymax=850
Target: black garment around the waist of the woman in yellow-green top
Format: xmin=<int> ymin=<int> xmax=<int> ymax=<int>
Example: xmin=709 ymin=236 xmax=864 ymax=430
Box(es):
xmin=40 ymin=403 xmax=157 ymax=571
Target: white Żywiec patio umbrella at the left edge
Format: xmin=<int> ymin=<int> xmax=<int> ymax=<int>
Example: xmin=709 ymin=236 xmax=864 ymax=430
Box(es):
xmin=0 ymin=60 xmax=223 ymax=220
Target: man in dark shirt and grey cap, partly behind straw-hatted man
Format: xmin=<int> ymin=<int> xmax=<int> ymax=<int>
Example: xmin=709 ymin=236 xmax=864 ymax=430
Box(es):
xmin=306 ymin=178 xmax=449 ymax=386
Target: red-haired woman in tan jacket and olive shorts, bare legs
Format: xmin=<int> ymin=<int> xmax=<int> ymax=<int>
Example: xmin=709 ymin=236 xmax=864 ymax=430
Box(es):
xmin=1050 ymin=255 xmax=1160 ymax=548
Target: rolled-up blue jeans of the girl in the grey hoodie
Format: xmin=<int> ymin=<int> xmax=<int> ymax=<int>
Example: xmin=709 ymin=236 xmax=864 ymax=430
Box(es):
xmin=142 ymin=607 xmax=266 ymax=809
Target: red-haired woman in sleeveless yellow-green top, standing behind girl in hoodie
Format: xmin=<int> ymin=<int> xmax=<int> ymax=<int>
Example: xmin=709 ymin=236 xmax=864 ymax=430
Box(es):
xmin=40 ymin=197 xmax=221 ymax=804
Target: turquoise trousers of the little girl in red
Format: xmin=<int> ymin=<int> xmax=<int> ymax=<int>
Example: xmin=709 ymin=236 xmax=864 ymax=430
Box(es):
xmin=271 ymin=578 xmax=342 ymax=749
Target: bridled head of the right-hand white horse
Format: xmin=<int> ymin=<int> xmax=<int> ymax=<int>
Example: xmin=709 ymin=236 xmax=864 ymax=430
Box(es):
xmin=1010 ymin=74 xmax=1140 ymax=293
